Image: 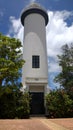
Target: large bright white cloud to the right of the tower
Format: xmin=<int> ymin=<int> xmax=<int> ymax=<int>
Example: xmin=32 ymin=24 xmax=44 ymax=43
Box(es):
xmin=46 ymin=11 xmax=73 ymax=72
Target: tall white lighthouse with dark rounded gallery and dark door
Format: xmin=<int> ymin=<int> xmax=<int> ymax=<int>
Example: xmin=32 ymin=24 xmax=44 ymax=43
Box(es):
xmin=21 ymin=3 xmax=48 ymax=114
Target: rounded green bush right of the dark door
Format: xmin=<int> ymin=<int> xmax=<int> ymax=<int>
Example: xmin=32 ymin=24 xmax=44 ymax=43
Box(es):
xmin=46 ymin=90 xmax=73 ymax=118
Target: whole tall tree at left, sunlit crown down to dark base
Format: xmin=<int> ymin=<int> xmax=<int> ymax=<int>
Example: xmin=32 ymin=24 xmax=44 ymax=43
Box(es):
xmin=0 ymin=34 xmax=24 ymax=118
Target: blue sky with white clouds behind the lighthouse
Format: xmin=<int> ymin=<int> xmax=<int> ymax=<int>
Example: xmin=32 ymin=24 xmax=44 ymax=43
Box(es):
xmin=0 ymin=0 xmax=73 ymax=89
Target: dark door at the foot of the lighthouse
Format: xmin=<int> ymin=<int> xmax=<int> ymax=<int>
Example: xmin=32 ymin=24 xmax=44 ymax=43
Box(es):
xmin=30 ymin=92 xmax=44 ymax=115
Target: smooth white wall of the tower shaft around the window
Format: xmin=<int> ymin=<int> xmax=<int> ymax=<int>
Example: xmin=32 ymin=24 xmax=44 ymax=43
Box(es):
xmin=23 ymin=13 xmax=48 ymax=85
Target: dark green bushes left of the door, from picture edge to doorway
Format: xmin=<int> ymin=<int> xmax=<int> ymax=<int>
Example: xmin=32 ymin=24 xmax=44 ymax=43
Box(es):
xmin=0 ymin=90 xmax=30 ymax=119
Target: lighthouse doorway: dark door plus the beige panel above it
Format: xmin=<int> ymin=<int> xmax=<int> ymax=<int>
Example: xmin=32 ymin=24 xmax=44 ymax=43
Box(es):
xmin=28 ymin=84 xmax=45 ymax=115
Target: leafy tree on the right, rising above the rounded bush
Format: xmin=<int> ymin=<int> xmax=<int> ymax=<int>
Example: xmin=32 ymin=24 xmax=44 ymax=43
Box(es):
xmin=55 ymin=43 xmax=73 ymax=95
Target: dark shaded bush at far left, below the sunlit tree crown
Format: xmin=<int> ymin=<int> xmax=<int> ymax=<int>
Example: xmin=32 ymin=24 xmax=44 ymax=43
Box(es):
xmin=0 ymin=88 xmax=16 ymax=119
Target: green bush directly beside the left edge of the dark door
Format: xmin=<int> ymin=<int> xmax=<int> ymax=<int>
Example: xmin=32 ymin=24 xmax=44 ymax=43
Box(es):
xmin=16 ymin=92 xmax=31 ymax=118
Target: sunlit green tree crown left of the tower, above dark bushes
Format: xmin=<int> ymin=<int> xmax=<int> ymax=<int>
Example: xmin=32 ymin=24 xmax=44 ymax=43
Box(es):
xmin=0 ymin=34 xmax=24 ymax=86
